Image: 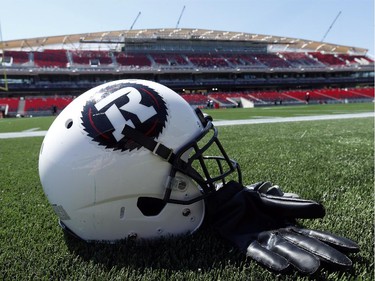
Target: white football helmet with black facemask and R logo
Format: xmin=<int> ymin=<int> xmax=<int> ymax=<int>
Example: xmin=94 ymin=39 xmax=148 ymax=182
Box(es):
xmin=39 ymin=80 xmax=241 ymax=242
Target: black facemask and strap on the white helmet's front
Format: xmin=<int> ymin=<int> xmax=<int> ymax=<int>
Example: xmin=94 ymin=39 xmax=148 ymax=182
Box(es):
xmin=124 ymin=109 xmax=242 ymax=205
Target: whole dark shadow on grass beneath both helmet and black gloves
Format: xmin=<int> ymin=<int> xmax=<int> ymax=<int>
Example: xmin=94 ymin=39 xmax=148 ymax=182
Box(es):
xmin=61 ymin=221 xmax=366 ymax=280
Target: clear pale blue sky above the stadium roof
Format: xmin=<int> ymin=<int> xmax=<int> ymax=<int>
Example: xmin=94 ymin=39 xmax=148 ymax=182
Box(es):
xmin=0 ymin=0 xmax=374 ymax=56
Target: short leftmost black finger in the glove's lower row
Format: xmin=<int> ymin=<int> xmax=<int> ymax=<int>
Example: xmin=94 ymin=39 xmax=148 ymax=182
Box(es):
xmin=246 ymin=241 xmax=289 ymax=273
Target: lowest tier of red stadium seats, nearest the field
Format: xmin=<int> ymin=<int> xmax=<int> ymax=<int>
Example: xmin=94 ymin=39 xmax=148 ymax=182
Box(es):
xmin=0 ymin=87 xmax=375 ymax=115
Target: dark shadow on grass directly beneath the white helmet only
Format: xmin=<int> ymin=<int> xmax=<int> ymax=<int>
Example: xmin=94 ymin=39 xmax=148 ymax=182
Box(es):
xmin=65 ymin=221 xmax=245 ymax=271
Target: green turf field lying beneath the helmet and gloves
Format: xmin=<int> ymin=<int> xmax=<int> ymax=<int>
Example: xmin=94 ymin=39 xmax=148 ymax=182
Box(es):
xmin=0 ymin=105 xmax=374 ymax=281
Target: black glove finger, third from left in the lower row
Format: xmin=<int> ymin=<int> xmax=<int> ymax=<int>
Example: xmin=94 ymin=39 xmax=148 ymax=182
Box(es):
xmin=279 ymin=228 xmax=352 ymax=269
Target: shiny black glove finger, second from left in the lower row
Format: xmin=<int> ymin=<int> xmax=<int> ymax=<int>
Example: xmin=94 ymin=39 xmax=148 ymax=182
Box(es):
xmin=258 ymin=231 xmax=320 ymax=274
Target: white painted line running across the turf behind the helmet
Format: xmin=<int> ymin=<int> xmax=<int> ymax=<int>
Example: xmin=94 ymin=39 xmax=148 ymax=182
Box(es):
xmin=0 ymin=112 xmax=375 ymax=139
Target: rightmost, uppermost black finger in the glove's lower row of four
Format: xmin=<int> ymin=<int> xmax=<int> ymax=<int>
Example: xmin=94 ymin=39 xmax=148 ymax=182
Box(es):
xmin=291 ymin=227 xmax=359 ymax=253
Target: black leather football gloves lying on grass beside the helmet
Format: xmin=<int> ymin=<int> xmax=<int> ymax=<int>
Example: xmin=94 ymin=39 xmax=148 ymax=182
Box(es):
xmin=206 ymin=181 xmax=359 ymax=274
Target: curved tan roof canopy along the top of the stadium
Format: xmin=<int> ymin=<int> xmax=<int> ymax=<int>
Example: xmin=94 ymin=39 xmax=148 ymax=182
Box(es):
xmin=2 ymin=28 xmax=368 ymax=55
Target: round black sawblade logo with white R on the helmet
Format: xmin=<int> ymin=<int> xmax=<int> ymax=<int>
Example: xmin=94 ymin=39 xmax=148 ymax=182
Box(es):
xmin=81 ymin=83 xmax=168 ymax=151
